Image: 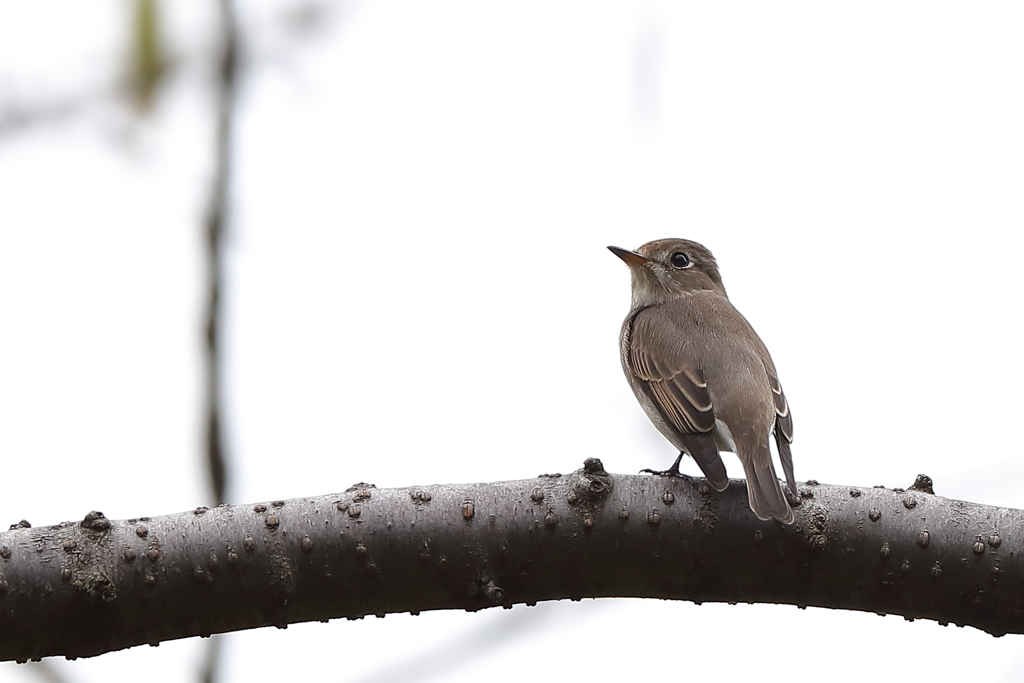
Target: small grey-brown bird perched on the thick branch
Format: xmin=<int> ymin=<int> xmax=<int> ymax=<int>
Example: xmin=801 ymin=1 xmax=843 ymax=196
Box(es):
xmin=608 ymin=240 xmax=797 ymax=524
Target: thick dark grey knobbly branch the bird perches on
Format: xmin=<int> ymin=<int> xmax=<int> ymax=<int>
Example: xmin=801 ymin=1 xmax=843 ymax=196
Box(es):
xmin=0 ymin=460 xmax=1024 ymax=660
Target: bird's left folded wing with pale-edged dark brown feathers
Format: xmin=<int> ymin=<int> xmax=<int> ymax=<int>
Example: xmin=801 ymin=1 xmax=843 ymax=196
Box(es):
xmin=627 ymin=317 xmax=729 ymax=490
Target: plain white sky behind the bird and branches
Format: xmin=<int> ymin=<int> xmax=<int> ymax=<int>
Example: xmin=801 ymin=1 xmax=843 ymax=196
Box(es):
xmin=0 ymin=0 xmax=1024 ymax=683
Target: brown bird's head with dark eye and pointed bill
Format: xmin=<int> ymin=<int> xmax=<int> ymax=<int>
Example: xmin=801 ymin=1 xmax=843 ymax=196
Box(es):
xmin=608 ymin=240 xmax=725 ymax=308
